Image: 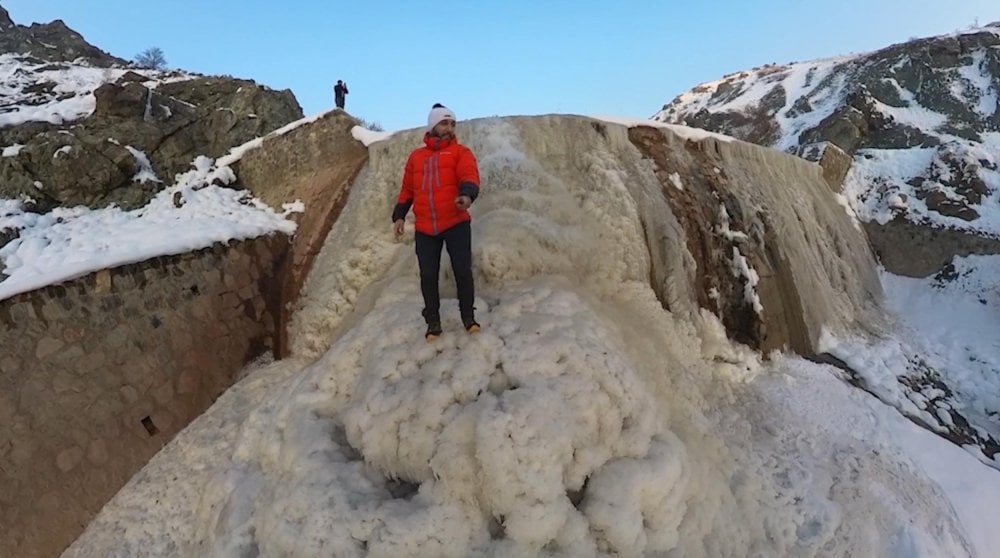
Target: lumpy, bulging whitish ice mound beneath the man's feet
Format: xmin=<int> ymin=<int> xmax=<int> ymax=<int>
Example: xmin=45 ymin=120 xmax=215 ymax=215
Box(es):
xmin=196 ymin=286 xmax=685 ymax=556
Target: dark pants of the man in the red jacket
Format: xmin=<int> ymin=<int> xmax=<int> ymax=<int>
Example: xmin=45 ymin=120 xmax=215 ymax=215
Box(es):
xmin=415 ymin=221 xmax=476 ymax=322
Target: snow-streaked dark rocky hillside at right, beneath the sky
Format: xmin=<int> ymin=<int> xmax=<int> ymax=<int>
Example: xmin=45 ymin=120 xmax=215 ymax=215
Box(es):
xmin=653 ymin=23 xmax=1000 ymax=238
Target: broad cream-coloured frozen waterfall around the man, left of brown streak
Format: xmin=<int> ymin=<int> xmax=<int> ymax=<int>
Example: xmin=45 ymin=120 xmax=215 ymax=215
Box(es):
xmin=66 ymin=117 xmax=1000 ymax=557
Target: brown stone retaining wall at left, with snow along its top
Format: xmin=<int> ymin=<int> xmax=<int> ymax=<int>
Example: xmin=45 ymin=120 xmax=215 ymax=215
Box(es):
xmin=0 ymin=235 xmax=289 ymax=558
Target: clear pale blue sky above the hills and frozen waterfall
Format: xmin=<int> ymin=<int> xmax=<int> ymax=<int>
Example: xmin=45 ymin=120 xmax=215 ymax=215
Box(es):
xmin=0 ymin=0 xmax=1000 ymax=130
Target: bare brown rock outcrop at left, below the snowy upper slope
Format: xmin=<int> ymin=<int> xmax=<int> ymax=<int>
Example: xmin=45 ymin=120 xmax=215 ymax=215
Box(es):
xmin=0 ymin=72 xmax=302 ymax=210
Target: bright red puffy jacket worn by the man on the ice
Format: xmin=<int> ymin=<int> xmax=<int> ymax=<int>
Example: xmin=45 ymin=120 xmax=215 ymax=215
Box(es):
xmin=392 ymin=134 xmax=479 ymax=236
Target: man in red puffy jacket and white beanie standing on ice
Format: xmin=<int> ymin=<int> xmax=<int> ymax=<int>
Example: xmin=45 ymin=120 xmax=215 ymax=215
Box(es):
xmin=392 ymin=103 xmax=479 ymax=340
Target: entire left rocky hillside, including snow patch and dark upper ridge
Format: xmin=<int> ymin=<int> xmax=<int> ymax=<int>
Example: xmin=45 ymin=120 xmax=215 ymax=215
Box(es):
xmin=0 ymin=12 xmax=302 ymax=217
